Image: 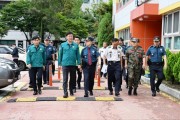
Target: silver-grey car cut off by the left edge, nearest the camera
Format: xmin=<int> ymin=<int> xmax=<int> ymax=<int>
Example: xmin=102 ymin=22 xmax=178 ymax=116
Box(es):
xmin=0 ymin=57 xmax=21 ymax=88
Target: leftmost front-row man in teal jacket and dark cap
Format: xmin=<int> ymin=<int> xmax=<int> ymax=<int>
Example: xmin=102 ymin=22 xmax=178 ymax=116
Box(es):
xmin=26 ymin=36 xmax=46 ymax=95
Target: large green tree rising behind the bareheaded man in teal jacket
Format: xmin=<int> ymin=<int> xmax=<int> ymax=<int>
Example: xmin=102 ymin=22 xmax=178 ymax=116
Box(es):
xmin=32 ymin=0 xmax=87 ymax=39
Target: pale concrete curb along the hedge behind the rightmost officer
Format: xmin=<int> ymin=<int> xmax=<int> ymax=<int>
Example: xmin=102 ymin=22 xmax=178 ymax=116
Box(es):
xmin=141 ymin=76 xmax=180 ymax=100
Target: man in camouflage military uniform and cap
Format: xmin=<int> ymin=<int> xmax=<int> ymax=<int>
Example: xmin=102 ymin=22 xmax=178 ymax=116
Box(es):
xmin=125 ymin=38 xmax=145 ymax=95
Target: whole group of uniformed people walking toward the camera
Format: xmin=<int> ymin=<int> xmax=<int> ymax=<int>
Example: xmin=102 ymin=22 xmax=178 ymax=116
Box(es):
xmin=27 ymin=32 xmax=167 ymax=98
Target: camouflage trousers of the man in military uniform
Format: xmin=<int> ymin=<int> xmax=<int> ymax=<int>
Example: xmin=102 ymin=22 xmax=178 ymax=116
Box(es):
xmin=128 ymin=66 xmax=141 ymax=88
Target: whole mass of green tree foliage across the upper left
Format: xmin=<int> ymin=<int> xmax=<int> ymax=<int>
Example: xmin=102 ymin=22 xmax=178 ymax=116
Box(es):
xmin=0 ymin=0 xmax=88 ymax=40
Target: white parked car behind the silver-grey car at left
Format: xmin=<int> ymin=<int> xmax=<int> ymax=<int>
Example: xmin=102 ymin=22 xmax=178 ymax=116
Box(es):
xmin=0 ymin=45 xmax=27 ymax=71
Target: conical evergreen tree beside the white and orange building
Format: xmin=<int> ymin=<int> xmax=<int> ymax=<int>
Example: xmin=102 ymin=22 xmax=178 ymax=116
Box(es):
xmin=98 ymin=13 xmax=113 ymax=46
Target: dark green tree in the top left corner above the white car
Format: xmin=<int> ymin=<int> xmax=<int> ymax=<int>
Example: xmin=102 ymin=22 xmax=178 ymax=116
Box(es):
xmin=0 ymin=0 xmax=38 ymax=40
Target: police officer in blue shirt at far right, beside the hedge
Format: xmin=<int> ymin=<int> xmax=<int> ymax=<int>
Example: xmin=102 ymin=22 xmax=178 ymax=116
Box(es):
xmin=146 ymin=36 xmax=167 ymax=97
